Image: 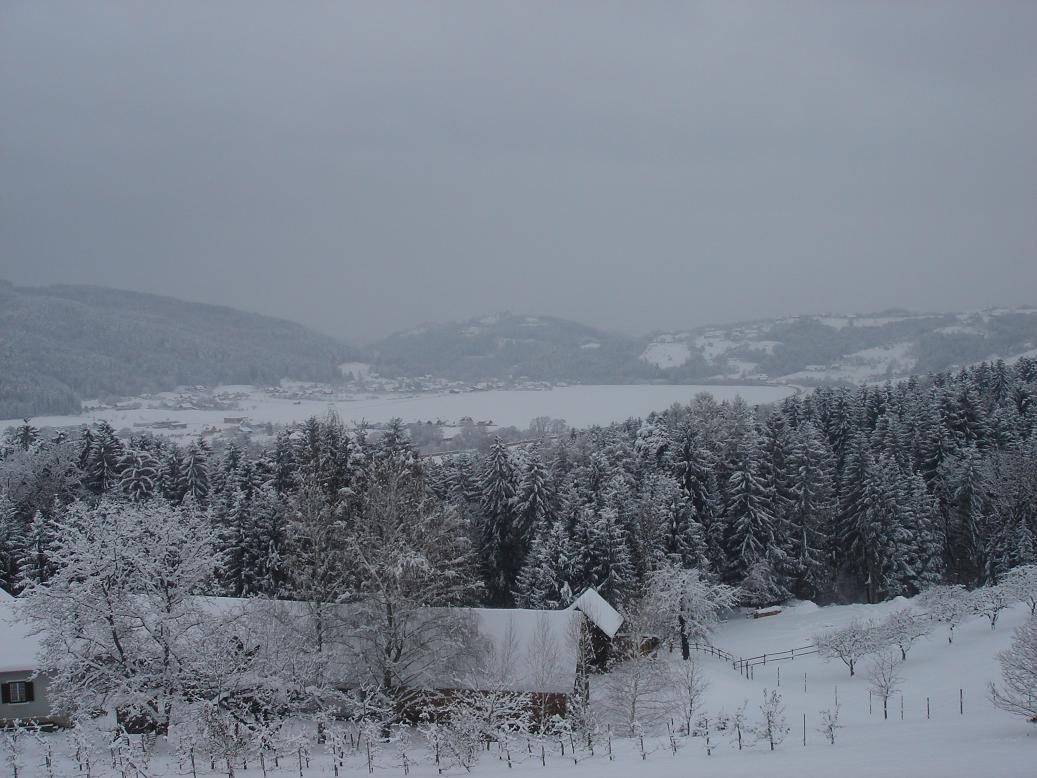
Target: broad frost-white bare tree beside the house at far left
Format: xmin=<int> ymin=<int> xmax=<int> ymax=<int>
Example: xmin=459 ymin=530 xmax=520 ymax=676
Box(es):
xmin=22 ymin=499 xmax=218 ymax=731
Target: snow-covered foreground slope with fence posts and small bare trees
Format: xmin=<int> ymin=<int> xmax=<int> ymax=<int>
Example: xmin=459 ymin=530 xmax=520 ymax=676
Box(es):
xmin=8 ymin=601 xmax=1037 ymax=778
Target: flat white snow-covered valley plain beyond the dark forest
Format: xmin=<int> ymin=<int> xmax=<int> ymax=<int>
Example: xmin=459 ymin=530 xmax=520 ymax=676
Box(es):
xmin=0 ymin=385 xmax=794 ymax=436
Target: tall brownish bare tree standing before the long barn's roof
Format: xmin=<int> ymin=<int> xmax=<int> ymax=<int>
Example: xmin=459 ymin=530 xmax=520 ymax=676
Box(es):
xmin=342 ymin=465 xmax=481 ymax=717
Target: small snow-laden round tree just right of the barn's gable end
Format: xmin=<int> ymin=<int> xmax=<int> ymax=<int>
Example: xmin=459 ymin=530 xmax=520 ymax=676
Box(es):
xmin=643 ymin=562 xmax=740 ymax=660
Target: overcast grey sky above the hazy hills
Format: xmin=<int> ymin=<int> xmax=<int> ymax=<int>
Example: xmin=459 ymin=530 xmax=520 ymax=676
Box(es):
xmin=0 ymin=0 xmax=1037 ymax=340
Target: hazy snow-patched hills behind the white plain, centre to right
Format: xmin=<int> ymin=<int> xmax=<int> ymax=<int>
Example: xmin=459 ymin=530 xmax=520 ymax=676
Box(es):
xmin=368 ymin=307 xmax=1037 ymax=386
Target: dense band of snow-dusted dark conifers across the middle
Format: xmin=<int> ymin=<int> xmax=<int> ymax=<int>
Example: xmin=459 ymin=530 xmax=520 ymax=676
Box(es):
xmin=0 ymin=359 xmax=1037 ymax=608
